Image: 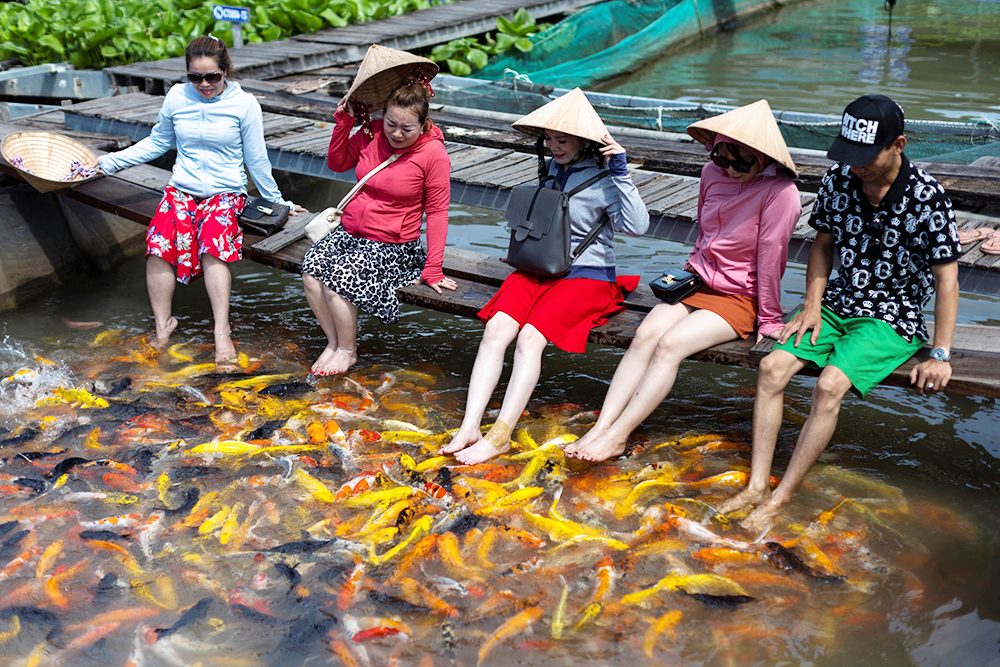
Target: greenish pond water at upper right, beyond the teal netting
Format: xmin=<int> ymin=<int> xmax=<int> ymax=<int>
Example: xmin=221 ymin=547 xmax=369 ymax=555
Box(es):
xmin=600 ymin=0 xmax=1000 ymax=122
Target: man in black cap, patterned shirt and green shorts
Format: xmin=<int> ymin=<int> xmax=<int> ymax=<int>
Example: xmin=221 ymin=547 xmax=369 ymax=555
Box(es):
xmin=720 ymin=95 xmax=960 ymax=532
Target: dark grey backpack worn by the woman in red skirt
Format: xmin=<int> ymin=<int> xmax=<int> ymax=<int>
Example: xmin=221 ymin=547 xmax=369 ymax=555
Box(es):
xmin=506 ymin=171 xmax=611 ymax=278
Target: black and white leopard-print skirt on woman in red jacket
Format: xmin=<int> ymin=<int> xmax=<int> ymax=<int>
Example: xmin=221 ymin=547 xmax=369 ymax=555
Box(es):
xmin=302 ymin=227 xmax=427 ymax=324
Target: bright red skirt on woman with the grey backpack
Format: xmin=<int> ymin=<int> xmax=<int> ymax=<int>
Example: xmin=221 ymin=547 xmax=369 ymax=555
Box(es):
xmin=479 ymin=271 xmax=639 ymax=352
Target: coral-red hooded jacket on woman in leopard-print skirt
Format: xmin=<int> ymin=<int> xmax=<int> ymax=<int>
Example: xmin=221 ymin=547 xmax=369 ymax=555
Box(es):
xmin=326 ymin=112 xmax=451 ymax=284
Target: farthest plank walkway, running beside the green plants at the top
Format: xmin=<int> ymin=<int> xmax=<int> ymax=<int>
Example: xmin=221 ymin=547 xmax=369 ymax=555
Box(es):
xmin=105 ymin=0 xmax=594 ymax=95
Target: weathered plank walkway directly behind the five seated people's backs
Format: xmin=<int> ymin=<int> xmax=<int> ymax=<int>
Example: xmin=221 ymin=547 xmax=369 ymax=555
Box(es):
xmin=62 ymin=93 xmax=1000 ymax=296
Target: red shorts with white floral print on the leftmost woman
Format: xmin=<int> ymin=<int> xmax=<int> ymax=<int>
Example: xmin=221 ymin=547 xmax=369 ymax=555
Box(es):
xmin=146 ymin=185 xmax=247 ymax=285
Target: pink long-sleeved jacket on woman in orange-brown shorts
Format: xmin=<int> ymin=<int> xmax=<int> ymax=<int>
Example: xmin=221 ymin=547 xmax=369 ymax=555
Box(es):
xmin=688 ymin=162 xmax=802 ymax=336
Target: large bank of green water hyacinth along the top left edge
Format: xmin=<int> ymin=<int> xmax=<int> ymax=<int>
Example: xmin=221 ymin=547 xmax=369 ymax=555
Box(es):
xmin=0 ymin=0 xmax=441 ymax=69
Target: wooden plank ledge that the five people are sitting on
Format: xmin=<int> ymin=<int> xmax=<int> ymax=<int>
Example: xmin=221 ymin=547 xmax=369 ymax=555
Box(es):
xmin=0 ymin=152 xmax=1000 ymax=398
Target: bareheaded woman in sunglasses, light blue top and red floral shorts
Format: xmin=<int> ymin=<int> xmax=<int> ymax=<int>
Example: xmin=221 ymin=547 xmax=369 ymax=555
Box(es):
xmin=99 ymin=36 xmax=302 ymax=364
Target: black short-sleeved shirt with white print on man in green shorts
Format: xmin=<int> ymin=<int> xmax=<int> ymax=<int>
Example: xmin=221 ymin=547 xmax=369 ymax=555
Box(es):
xmin=809 ymin=155 xmax=961 ymax=341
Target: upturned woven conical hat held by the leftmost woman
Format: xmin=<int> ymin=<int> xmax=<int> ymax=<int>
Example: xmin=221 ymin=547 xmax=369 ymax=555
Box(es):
xmin=0 ymin=132 xmax=97 ymax=192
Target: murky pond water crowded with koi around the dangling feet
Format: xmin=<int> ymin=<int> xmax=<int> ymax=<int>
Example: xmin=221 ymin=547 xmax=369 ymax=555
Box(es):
xmin=0 ymin=177 xmax=1000 ymax=666
